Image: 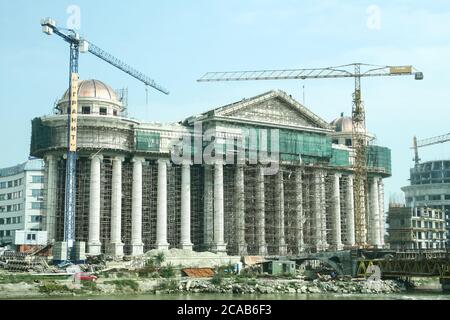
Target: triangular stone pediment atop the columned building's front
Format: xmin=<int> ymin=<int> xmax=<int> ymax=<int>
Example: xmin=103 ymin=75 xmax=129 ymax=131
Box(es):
xmin=214 ymin=91 xmax=330 ymax=129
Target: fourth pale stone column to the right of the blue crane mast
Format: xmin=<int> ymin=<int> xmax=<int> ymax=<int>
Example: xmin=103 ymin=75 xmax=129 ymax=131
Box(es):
xmin=156 ymin=159 xmax=169 ymax=250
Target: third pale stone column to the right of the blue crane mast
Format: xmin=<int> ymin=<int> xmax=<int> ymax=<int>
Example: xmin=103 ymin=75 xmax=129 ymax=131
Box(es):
xmin=131 ymin=157 xmax=145 ymax=256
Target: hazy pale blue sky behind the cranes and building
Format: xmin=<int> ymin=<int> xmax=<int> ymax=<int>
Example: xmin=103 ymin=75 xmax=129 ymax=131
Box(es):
xmin=0 ymin=0 xmax=450 ymax=204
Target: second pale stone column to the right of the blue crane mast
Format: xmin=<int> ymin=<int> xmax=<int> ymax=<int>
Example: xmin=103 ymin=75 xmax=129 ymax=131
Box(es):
xmin=108 ymin=157 xmax=124 ymax=257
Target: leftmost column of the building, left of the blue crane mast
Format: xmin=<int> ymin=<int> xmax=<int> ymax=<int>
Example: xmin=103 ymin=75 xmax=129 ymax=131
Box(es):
xmin=45 ymin=155 xmax=58 ymax=241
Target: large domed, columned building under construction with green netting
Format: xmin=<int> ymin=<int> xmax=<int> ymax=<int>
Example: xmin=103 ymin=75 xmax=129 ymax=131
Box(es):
xmin=31 ymin=80 xmax=391 ymax=256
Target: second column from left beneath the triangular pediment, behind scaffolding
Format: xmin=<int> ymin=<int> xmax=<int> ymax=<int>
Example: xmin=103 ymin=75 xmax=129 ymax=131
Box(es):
xmin=234 ymin=164 xmax=247 ymax=256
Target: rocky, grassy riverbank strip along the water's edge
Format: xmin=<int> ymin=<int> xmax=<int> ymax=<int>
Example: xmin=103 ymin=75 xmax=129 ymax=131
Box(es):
xmin=0 ymin=277 xmax=405 ymax=299
